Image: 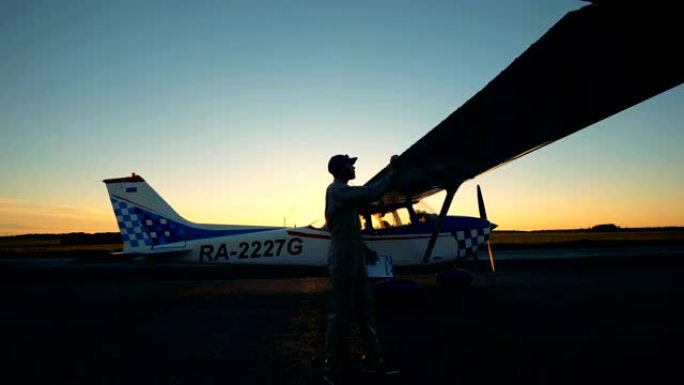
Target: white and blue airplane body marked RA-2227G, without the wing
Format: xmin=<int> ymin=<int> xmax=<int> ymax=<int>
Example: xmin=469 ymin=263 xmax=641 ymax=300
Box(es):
xmin=104 ymin=173 xmax=496 ymax=277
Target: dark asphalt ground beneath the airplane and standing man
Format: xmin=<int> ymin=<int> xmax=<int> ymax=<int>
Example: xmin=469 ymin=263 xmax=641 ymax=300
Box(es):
xmin=0 ymin=248 xmax=684 ymax=384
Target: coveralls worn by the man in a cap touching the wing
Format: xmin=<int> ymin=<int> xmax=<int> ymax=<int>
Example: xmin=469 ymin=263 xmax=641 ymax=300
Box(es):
xmin=325 ymin=175 xmax=390 ymax=371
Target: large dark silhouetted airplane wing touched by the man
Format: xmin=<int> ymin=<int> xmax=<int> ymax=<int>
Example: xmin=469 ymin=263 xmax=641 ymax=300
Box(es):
xmin=366 ymin=1 xmax=684 ymax=206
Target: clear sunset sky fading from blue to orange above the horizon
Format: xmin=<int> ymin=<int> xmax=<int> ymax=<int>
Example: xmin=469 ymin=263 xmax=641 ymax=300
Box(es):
xmin=0 ymin=0 xmax=684 ymax=235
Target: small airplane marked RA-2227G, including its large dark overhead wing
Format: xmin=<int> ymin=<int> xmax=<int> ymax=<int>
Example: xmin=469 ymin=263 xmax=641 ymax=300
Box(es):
xmin=104 ymin=1 xmax=684 ymax=284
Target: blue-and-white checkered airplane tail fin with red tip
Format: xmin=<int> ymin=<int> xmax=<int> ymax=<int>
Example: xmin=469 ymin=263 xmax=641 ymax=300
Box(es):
xmin=103 ymin=173 xmax=274 ymax=254
